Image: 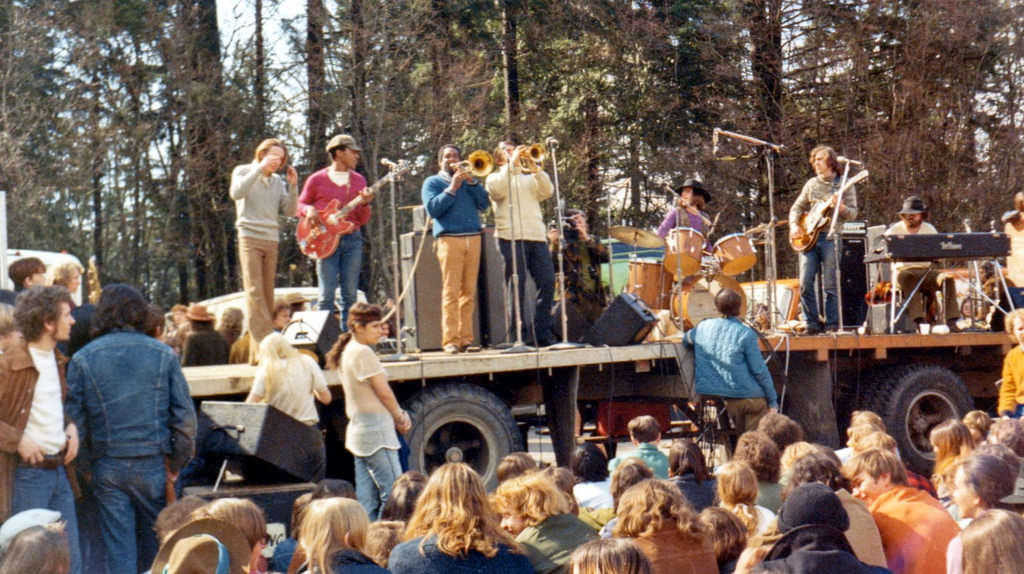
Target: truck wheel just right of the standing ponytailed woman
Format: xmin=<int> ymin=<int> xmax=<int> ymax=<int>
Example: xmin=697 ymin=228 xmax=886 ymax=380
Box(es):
xmin=409 ymin=384 xmax=522 ymax=488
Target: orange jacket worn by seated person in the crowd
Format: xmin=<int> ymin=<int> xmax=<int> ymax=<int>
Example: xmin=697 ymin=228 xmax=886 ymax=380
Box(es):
xmin=868 ymin=486 xmax=959 ymax=574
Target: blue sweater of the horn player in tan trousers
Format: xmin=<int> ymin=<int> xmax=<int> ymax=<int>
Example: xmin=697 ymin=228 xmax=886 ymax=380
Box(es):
xmin=421 ymin=172 xmax=490 ymax=237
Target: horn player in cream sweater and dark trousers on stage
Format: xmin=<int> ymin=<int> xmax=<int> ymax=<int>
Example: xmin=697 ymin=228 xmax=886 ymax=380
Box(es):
xmin=486 ymin=141 xmax=555 ymax=347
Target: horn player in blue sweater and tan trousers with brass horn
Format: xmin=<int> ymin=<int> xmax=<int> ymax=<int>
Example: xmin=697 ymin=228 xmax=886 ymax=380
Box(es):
xmin=421 ymin=144 xmax=493 ymax=354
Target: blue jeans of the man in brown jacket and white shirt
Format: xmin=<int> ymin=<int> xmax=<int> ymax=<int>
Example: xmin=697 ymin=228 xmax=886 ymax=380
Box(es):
xmin=10 ymin=465 xmax=80 ymax=574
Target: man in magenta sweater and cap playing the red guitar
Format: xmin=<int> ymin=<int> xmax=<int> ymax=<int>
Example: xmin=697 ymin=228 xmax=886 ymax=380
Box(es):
xmin=297 ymin=134 xmax=372 ymax=330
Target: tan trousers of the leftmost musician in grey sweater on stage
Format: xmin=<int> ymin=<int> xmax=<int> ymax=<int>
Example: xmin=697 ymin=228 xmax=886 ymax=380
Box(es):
xmin=239 ymin=236 xmax=278 ymax=355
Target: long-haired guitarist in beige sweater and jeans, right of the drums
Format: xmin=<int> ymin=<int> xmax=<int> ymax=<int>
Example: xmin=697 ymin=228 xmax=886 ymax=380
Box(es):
xmin=790 ymin=145 xmax=857 ymax=335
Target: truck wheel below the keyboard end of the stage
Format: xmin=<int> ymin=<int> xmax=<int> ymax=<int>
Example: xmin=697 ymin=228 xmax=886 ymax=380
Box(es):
xmin=865 ymin=363 xmax=974 ymax=477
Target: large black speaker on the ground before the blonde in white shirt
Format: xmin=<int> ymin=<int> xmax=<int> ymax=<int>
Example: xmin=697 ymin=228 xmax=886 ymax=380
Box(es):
xmin=199 ymin=401 xmax=326 ymax=484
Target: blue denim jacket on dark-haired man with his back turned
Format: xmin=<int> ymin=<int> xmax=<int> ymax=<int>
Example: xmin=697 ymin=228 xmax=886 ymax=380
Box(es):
xmin=66 ymin=330 xmax=196 ymax=471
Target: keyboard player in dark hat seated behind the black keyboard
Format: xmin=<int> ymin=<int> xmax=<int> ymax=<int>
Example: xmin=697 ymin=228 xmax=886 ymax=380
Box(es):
xmin=886 ymin=195 xmax=959 ymax=333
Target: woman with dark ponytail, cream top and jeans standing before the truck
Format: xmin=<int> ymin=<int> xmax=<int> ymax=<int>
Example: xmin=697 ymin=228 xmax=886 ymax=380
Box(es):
xmin=327 ymin=303 xmax=413 ymax=521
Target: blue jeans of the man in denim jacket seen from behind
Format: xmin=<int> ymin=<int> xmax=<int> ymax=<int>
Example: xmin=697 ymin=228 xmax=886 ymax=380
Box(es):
xmin=93 ymin=455 xmax=167 ymax=574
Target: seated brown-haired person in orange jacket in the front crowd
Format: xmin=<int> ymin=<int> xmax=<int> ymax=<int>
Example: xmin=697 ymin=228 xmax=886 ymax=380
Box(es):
xmin=843 ymin=449 xmax=959 ymax=574
